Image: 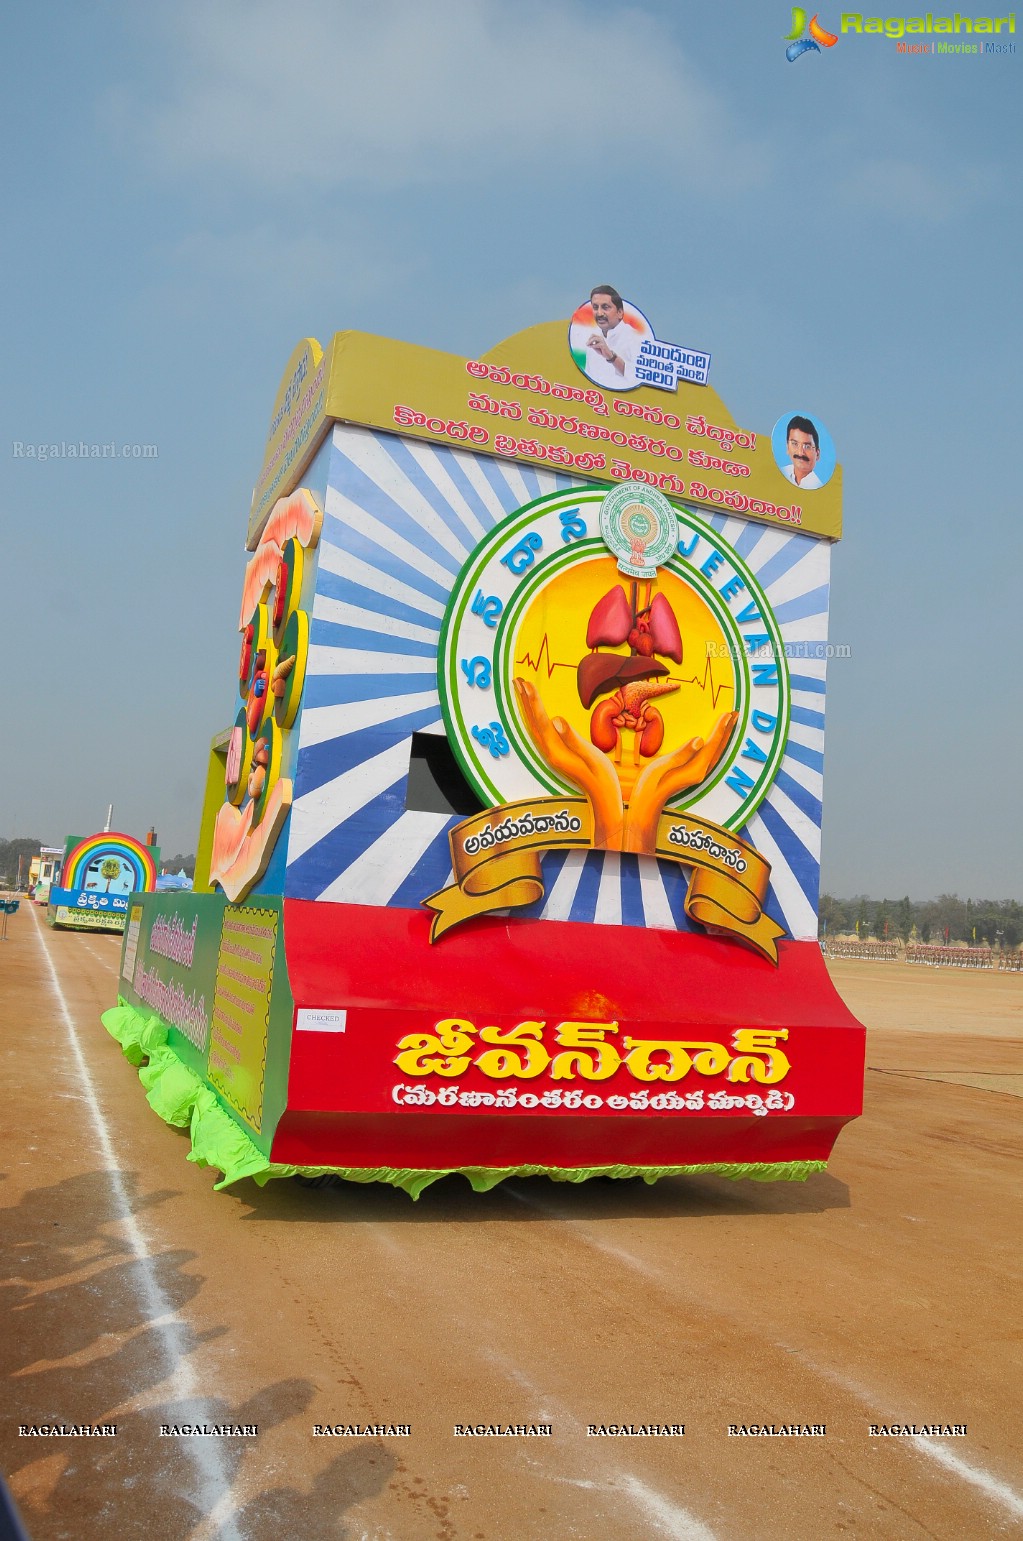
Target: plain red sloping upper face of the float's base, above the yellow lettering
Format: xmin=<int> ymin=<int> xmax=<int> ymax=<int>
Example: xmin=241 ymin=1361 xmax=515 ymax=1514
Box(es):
xmin=283 ymin=898 xmax=863 ymax=1032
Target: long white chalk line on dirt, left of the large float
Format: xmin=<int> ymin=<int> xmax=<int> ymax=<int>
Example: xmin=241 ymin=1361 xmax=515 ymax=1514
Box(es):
xmin=32 ymin=914 xmax=245 ymax=1541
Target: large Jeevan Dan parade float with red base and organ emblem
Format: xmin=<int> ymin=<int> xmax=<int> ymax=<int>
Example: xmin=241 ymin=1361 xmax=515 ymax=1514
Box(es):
xmin=103 ymin=290 xmax=864 ymax=1196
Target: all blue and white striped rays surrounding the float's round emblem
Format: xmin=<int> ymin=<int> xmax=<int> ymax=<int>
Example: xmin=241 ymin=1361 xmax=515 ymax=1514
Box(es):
xmin=285 ymin=425 xmax=829 ymax=937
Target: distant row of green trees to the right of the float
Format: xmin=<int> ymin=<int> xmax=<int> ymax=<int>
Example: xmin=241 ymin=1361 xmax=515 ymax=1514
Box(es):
xmin=818 ymin=894 xmax=1023 ymax=948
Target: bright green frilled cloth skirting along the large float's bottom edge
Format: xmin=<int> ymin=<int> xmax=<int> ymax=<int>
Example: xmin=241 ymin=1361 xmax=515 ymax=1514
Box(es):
xmin=103 ymin=999 xmax=827 ymax=1199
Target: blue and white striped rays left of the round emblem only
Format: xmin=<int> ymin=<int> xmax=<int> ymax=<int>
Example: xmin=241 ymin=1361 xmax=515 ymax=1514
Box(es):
xmin=285 ymin=427 xmax=572 ymax=909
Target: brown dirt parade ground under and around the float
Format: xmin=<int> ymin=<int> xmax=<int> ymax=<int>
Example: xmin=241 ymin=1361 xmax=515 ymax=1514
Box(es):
xmin=0 ymin=901 xmax=1023 ymax=1541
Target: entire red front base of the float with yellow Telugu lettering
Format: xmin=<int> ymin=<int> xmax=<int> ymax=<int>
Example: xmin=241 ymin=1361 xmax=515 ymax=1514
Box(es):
xmin=273 ymin=900 xmax=864 ymax=1168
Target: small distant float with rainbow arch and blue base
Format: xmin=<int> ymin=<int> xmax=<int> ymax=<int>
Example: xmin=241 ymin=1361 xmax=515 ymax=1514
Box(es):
xmin=46 ymin=829 xmax=160 ymax=931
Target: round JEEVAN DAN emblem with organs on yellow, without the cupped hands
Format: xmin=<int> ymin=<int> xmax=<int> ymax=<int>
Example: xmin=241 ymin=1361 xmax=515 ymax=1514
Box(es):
xmin=439 ymin=487 xmax=789 ymax=831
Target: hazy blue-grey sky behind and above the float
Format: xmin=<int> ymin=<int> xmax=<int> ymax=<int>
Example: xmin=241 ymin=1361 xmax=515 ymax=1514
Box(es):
xmin=0 ymin=0 xmax=1023 ymax=898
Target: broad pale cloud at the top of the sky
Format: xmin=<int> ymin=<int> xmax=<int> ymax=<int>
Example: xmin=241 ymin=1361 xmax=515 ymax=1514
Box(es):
xmin=106 ymin=0 xmax=763 ymax=191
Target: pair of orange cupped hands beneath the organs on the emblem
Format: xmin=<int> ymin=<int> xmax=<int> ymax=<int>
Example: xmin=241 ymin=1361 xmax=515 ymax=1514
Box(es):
xmin=515 ymin=680 xmax=740 ymax=855
